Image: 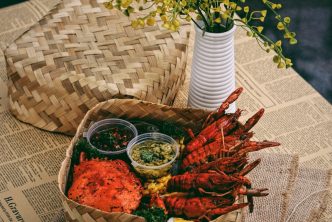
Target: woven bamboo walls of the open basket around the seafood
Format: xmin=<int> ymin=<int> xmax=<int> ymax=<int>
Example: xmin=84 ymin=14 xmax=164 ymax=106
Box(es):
xmin=58 ymin=99 xmax=241 ymax=222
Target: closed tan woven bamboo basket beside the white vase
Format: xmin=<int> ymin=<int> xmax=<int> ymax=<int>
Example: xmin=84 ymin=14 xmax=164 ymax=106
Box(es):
xmin=5 ymin=0 xmax=190 ymax=134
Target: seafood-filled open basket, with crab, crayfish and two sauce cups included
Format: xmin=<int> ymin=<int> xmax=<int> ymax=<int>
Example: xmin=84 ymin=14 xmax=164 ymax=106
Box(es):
xmin=59 ymin=88 xmax=279 ymax=222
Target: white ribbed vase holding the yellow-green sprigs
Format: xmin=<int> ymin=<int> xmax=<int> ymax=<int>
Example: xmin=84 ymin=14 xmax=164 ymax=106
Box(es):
xmin=188 ymin=25 xmax=236 ymax=112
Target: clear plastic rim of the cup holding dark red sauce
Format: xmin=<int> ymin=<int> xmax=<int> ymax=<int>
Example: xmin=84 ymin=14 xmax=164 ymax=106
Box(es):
xmin=84 ymin=118 xmax=138 ymax=155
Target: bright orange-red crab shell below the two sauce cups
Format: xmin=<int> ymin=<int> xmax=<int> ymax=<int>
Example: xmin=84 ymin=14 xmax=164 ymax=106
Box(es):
xmin=68 ymin=159 xmax=142 ymax=213
